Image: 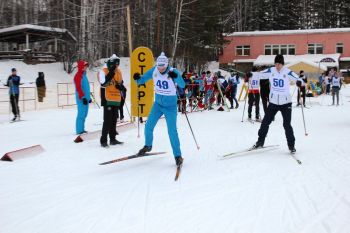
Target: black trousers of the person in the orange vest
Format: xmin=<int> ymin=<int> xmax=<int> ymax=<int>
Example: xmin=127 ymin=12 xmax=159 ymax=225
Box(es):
xmin=100 ymin=106 xmax=119 ymax=144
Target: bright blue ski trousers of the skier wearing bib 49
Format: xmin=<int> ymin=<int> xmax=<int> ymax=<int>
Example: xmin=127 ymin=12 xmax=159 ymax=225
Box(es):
xmin=145 ymin=102 xmax=181 ymax=157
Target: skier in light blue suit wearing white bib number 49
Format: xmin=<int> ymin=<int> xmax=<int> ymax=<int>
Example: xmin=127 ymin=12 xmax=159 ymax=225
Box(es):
xmin=133 ymin=52 xmax=185 ymax=166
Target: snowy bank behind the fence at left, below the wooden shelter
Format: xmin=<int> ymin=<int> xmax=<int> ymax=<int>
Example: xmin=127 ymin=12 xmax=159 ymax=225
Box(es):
xmin=0 ymin=57 xmax=130 ymax=114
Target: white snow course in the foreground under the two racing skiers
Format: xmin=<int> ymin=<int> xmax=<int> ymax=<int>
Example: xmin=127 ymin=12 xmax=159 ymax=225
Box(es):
xmin=0 ymin=86 xmax=350 ymax=233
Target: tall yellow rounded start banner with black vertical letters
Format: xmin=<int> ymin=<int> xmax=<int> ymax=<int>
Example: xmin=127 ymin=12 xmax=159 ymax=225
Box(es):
xmin=130 ymin=47 xmax=154 ymax=117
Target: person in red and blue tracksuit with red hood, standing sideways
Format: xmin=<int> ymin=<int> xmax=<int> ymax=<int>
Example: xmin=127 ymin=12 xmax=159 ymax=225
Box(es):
xmin=74 ymin=60 xmax=91 ymax=134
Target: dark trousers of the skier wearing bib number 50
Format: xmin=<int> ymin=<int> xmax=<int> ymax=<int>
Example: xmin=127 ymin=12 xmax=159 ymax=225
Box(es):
xmin=258 ymin=103 xmax=295 ymax=146
